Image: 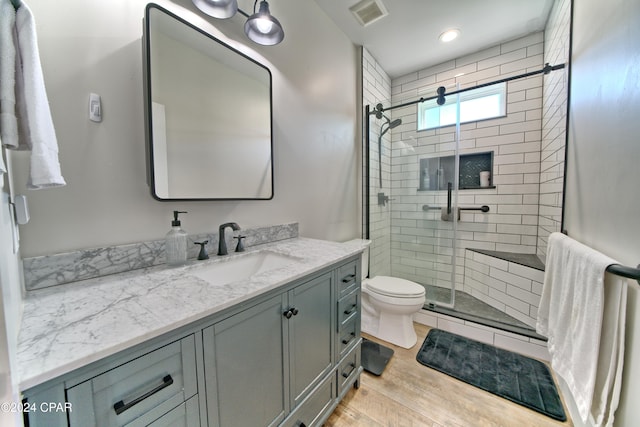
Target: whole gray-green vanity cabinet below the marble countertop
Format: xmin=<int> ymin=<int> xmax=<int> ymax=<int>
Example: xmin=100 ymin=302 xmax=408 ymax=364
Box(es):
xmin=24 ymin=256 xmax=362 ymax=427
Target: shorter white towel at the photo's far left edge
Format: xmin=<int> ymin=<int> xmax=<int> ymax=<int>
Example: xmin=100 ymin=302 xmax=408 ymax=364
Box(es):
xmin=0 ymin=0 xmax=18 ymax=148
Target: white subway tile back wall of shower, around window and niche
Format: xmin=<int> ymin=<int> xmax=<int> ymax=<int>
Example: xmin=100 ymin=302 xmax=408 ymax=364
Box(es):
xmin=391 ymin=32 xmax=544 ymax=290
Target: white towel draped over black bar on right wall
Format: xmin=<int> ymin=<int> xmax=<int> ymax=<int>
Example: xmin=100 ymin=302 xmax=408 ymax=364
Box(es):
xmin=536 ymin=233 xmax=627 ymax=426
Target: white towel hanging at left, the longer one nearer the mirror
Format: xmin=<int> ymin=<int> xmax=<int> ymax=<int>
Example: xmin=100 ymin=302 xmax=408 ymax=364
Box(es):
xmin=16 ymin=2 xmax=66 ymax=189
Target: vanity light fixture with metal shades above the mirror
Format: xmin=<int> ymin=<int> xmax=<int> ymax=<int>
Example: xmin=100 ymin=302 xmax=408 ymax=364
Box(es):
xmin=191 ymin=0 xmax=284 ymax=46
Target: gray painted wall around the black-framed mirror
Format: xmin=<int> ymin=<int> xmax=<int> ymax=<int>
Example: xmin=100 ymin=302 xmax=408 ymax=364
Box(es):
xmin=14 ymin=0 xmax=360 ymax=257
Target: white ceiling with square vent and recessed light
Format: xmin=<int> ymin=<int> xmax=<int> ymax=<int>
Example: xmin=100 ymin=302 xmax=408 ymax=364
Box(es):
xmin=315 ymin=0 xmax=554 ymax=78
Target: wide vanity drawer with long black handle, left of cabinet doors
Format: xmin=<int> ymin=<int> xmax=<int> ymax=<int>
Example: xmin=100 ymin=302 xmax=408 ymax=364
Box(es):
xmin=67 ymin=335 xmax=198 ymax=427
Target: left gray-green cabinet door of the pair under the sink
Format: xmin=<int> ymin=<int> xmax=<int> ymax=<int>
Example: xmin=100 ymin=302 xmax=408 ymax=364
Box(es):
xmin=203 ymin=295 xmax=289 ymax=427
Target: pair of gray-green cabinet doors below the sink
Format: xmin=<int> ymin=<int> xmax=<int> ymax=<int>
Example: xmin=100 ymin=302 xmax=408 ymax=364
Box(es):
xmin=203 ymin=272 xmax=335 ymax=427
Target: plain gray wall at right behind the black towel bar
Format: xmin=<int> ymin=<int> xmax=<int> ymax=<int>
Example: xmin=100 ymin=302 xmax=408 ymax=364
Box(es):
xmin=565 ymin=0 xmax=640 ymax=426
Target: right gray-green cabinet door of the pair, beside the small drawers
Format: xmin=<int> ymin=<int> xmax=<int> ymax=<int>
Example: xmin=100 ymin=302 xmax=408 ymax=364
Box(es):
xmin=288 ymin=273 xmax=335 ymax=407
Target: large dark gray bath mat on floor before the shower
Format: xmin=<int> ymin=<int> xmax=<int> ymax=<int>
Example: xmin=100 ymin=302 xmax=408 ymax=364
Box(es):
xmin=416 ymin=329 xmax=567 ymax=421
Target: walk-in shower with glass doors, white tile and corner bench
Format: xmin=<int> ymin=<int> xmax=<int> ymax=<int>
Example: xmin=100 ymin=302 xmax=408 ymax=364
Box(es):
xmin=364 ymin=54 xmax=566 ymax=336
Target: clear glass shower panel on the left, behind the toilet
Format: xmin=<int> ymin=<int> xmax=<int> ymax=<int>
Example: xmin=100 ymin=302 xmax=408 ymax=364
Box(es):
xmin=366 ymin=87 xmax=461 ymax=307
